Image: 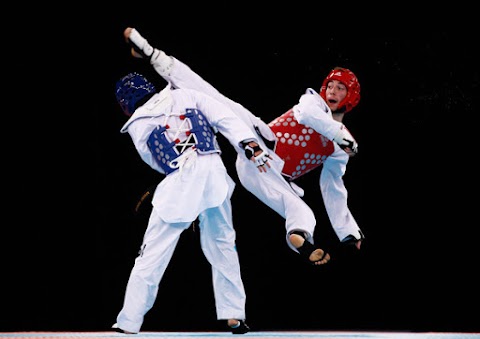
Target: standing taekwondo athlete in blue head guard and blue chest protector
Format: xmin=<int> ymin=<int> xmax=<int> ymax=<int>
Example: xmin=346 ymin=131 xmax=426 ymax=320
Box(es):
xmin=113 ymin=69 xmax=269 ymax=334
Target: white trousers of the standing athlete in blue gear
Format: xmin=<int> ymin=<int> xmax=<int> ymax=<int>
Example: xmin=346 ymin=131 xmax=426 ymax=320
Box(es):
xmin=117 ymin=197 xmax=246 ymax=333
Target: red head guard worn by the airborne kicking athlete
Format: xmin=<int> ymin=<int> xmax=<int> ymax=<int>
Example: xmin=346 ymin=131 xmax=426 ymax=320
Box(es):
xmin=320 ymin=67 xmax=360 ymax=113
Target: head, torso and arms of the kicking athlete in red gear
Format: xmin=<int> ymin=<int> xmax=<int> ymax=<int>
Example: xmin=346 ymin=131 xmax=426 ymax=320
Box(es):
xmin=269 ymin=67 xmax=364 ymax=249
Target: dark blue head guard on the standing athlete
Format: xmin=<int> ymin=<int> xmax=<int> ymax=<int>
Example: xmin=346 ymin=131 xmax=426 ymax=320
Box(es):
xmin=115 ymin=72 xmax=156 ymax=116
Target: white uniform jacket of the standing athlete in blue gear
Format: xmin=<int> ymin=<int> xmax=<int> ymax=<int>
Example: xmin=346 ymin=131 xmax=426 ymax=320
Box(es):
xmin=121 ymin=84 xmax=257 ymax=223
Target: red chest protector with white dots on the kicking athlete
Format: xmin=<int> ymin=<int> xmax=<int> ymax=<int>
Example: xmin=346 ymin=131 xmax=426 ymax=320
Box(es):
xmin=268 ymin=109 xmax=334 ymax=180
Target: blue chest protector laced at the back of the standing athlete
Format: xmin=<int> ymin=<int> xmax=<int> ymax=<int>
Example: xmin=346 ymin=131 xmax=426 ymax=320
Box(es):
xmin=147 ymin=108 xmax=220 ymax=175
